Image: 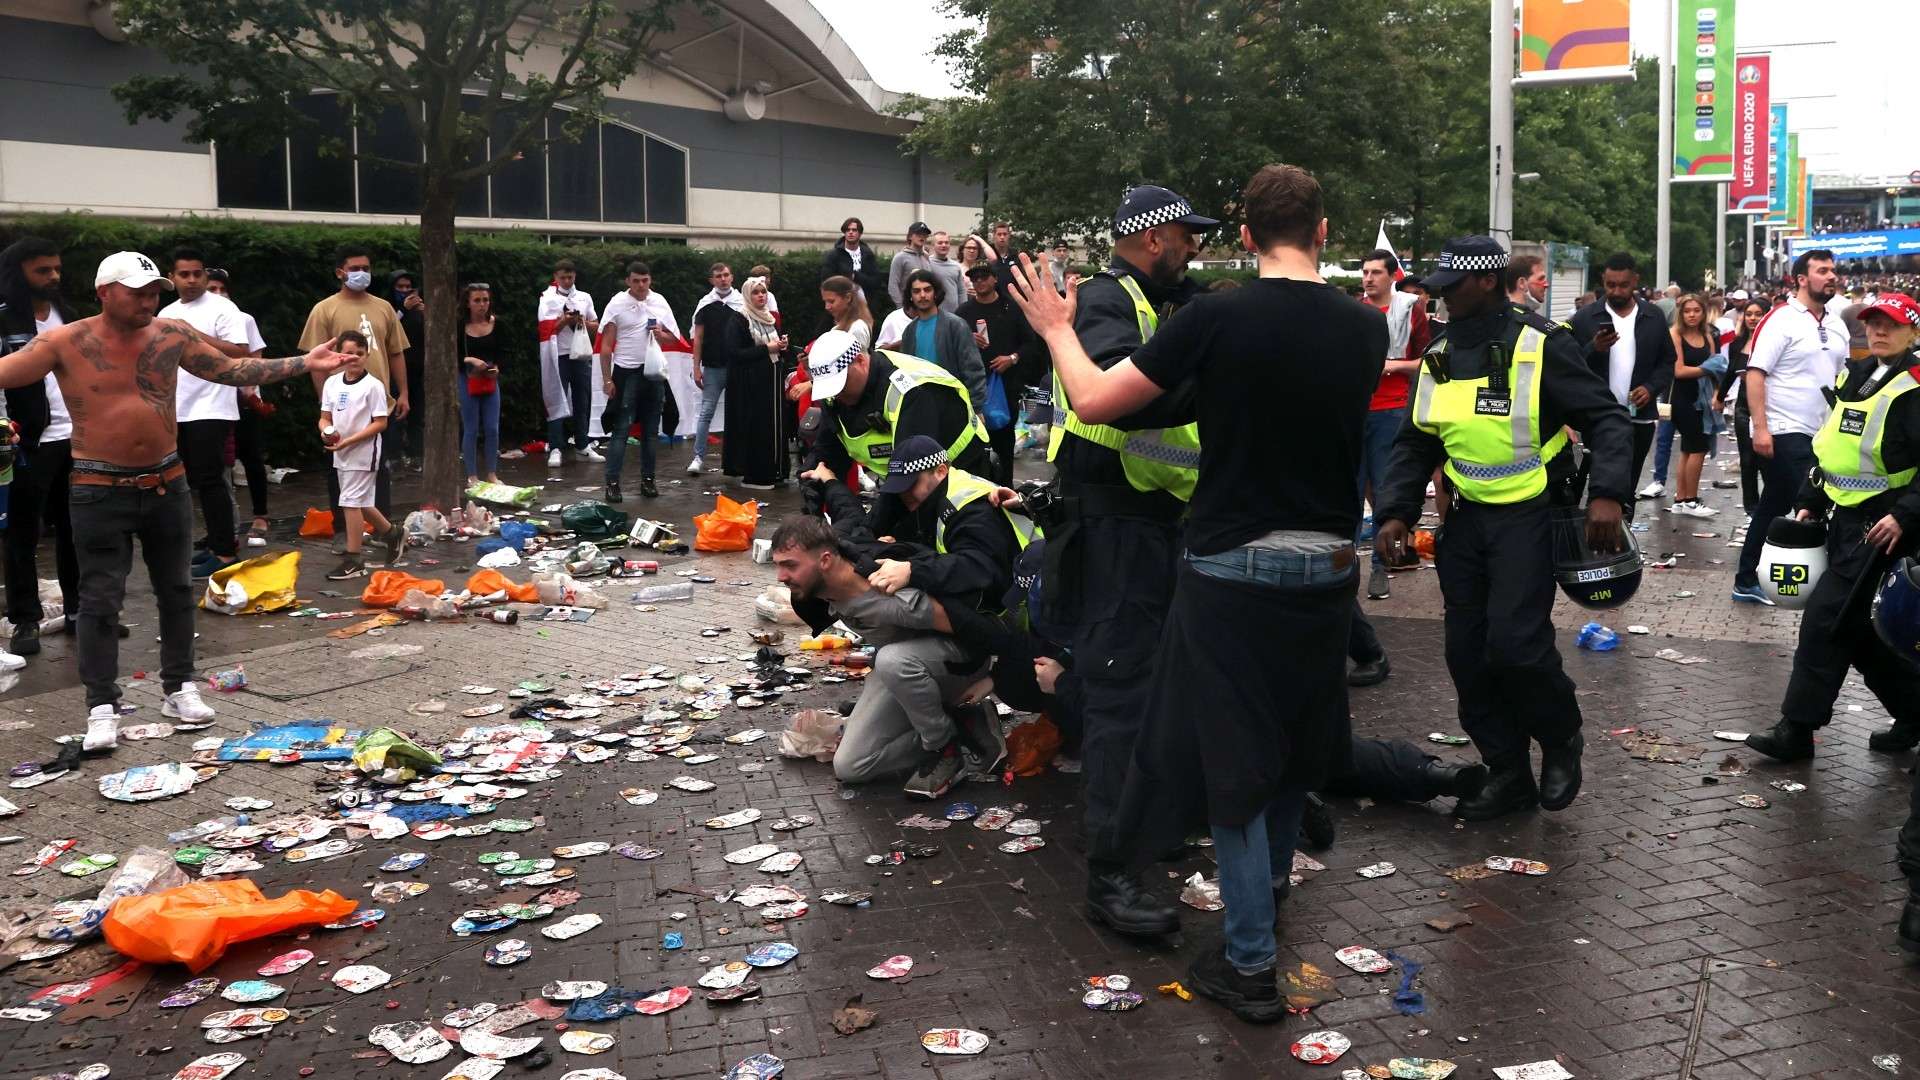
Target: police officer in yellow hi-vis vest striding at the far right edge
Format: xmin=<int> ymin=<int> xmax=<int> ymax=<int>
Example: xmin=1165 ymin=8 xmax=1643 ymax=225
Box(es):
xmin=1747 ymin=292 xmax=1920 ymax=764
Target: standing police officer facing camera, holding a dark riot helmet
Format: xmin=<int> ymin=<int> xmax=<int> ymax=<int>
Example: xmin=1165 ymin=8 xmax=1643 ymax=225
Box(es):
xmin=1375 ymin=236 xmax=1634 ymax=821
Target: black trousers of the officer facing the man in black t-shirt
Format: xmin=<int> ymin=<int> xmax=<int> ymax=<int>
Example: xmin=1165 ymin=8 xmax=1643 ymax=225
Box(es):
xmin=1075 ymin=517 xmax=1181 ymax=863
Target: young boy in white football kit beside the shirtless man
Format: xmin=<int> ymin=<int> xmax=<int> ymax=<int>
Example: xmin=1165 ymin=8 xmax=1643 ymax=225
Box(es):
xmin=321 ymin=331 xmax=407 ymax=580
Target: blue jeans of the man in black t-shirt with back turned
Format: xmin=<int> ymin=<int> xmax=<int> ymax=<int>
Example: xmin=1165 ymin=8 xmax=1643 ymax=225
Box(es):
xmin=1187 ymin=548 xmax=1359 ymax=972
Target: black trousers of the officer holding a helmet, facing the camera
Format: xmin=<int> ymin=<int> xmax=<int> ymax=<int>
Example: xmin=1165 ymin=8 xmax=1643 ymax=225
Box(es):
xmin=1434 ymin=498 xmax=1580 ymax=769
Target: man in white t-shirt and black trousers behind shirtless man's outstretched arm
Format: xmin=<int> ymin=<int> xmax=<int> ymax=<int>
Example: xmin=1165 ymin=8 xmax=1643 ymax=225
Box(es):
xmin=157 ymin=248 xmax=253 ymax=578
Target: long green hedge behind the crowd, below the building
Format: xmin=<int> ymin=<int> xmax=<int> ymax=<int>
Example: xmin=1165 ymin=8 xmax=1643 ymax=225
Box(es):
xmin=0 ymin=213 xmax=921 ymax=465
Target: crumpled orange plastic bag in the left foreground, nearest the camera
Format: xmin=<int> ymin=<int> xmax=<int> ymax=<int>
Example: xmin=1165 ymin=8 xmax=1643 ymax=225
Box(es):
xmin=100 ymin=878 xmax=359 ymax=974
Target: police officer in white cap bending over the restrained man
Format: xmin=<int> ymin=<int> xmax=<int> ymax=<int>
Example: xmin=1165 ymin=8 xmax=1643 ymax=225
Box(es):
xmin=806 ymin=331 xmax=993 ymax=477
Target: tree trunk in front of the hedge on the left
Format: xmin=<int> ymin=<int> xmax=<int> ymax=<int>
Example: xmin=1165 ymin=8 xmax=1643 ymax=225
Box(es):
xmin=413 ymin=173 xmax=467 ymax=517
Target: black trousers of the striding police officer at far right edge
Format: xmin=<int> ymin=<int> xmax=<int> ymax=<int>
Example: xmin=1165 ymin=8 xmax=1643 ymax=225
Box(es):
xmin=1780 ymin=509 xmax=1920 ymax=728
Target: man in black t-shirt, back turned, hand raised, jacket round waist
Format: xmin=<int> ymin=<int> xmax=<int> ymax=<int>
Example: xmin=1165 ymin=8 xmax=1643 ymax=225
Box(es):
xmin=1014 ymin=165 xmax=1386 ymax=1022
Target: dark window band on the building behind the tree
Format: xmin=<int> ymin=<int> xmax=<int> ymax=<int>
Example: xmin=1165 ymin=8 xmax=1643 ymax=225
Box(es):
xmin=215 ymin=92 xmax=687 ymax=225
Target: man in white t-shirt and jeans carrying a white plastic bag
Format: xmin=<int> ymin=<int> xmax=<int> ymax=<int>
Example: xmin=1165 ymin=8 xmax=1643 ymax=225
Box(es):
xmin=601 ymin=261 xmax=685 ymax=502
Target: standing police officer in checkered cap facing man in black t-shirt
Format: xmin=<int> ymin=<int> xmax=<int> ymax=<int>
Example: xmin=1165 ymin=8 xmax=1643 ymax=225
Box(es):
xmin=1043 ymin=184 xmax=1219 ymax=934
